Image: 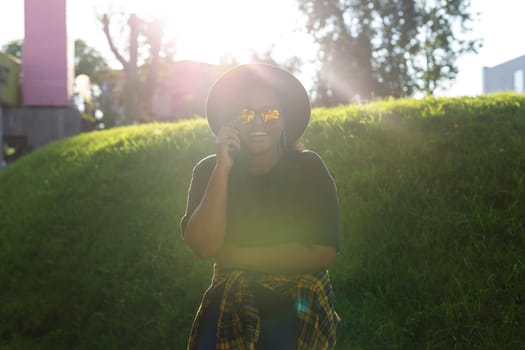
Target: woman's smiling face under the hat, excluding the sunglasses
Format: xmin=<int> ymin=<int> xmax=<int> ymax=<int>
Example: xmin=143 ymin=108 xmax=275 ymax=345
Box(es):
xmin=238 ymin=87 xmax=284 ymax=155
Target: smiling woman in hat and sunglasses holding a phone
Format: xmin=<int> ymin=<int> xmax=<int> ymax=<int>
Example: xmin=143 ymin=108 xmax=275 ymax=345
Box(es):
xmin=181 ymin=64 xmax=339 ymax=350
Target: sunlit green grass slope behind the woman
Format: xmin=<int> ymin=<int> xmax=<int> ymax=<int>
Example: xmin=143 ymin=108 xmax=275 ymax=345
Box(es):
xmin=0 ymin=94 xmax=525 ymax=349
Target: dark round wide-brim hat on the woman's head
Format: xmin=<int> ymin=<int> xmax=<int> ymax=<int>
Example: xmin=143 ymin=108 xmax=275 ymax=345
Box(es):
xmin=206 ymin=63 xmax=311 ymax=142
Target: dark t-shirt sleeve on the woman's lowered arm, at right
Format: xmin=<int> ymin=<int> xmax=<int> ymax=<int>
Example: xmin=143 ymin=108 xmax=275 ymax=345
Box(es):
xmin=302 ymin=151 xmax=340 ymax=250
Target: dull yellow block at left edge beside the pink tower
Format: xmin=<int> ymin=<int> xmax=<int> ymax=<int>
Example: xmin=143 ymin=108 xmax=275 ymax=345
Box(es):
xmin=0 ymin=52 xmax=20 ymax=107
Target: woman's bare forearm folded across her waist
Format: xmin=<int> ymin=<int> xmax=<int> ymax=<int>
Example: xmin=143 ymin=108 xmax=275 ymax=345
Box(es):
xmin=216 ymin=243 xmax=336 ymax=273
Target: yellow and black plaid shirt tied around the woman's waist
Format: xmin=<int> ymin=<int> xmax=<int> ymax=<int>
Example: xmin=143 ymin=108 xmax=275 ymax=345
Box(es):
xmin=188 ymin=268 xmax=340 ymax=350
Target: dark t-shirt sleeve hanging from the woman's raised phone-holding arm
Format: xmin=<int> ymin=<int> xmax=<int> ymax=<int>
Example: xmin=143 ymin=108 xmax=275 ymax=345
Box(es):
xmin=180 ymin=156 xmax=215 ymax=239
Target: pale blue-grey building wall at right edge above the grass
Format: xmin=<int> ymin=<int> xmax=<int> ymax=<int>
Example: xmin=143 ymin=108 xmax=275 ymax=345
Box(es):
xmin=483 ymin=55 xmax=525 ymax=93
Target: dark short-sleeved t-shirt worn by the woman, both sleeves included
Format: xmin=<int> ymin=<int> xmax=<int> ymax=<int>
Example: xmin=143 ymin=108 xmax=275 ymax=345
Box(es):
xmin=181 ymin=151 xmax=339 ymax=249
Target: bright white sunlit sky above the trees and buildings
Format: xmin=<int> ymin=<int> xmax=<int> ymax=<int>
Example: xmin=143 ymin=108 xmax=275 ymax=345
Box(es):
xmin=0 ymin=0 xmax=525 ymax=96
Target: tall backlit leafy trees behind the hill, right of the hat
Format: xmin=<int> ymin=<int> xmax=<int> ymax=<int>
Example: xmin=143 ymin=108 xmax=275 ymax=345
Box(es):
xmin=297 ymin=0 xmax=480 ymax=105
